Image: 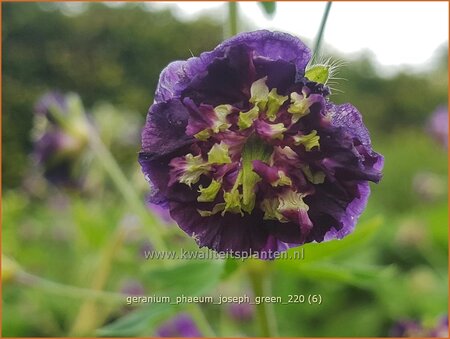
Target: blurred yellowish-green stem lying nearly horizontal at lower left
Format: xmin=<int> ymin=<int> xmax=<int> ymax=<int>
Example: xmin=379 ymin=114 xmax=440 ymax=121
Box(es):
xmin=16 ymin=271 xmax=125 ymax=304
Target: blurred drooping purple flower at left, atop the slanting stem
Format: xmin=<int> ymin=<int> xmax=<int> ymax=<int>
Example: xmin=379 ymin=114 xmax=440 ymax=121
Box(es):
xmin=33 ymin=92 xmax=87 ymax=186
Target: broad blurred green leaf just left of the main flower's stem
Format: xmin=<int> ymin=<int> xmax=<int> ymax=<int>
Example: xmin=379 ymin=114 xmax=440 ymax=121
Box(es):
xmin=97 ymin=260 xmax=224 ymax=337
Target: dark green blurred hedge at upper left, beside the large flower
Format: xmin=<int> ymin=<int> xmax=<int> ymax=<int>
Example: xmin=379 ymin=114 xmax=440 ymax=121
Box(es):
xmin=2 ymin=3 xmax=222 ymax=187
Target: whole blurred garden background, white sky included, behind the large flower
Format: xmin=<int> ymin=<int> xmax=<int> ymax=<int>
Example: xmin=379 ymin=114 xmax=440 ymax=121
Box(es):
xmin=2 ymin=2 xmax=448 ymax=337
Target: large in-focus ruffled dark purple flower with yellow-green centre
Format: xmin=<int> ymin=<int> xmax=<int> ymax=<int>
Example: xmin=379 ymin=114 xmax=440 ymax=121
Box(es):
xmin=139 ymin=31 xmax=383 ymax=256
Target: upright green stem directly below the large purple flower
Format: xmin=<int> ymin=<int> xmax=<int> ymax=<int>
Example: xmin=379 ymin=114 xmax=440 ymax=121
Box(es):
xmin=248 ymin=261 xmax=278 ymax=338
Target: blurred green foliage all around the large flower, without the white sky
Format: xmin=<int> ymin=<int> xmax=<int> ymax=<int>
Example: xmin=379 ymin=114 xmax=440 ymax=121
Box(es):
xmin=2 ymin=3 xmax=448 ymax=337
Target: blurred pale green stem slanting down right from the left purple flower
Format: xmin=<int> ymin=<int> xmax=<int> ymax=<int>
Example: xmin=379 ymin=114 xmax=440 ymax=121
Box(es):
xmin=86 ymin=119 xmax=166 ymax=251
